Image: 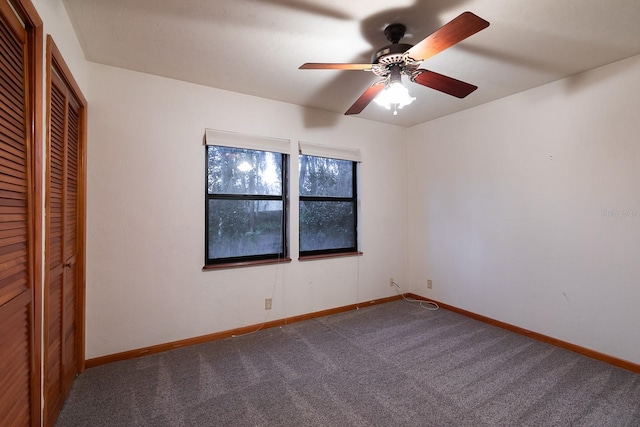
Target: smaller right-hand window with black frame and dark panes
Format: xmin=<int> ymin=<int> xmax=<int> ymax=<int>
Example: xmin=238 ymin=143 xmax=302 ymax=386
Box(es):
xmin=299 ymin=154 xmax=358 ymax=257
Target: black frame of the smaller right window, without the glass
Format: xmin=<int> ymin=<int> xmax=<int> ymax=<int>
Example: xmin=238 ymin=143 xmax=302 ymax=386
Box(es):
xmin=298 ymin=155 xmax=362 ymax=260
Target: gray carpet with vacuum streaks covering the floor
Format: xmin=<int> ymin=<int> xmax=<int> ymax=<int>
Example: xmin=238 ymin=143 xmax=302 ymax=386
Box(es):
xmin=56 ymin=301 xmax=640 ymax=427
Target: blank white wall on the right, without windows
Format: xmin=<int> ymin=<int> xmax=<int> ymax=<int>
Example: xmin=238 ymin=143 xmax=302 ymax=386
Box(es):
xmin=408 ymin=52 xmax=640 ymax=363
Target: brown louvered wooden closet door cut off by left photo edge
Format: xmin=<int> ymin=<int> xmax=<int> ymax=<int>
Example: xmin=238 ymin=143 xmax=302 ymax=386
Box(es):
xmin=0 ymin=0 xmax=34 ymax=426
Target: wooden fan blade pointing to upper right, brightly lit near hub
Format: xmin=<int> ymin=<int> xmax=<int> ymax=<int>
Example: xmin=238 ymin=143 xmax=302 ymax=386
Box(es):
xmin=406 ymin=12 xmax=489 ymax=61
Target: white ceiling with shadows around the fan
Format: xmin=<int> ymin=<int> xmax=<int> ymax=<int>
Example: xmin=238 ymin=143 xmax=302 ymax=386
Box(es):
xmin=63 ymin=0 xmax=640 ymax=126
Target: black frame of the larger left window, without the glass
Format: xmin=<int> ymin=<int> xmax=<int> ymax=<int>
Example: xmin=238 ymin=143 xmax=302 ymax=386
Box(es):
xmin=203 ymin=144 xmax=291 ymax=270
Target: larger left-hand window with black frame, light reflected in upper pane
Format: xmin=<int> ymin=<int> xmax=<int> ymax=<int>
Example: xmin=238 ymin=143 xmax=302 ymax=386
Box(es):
xmin=205 ymin=134 xmax=288 ymax=266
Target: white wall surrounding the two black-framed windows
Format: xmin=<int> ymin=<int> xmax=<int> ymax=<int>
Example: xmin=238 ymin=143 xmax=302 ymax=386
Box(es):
xmin=86 ymin=63 xmax=407 ymax=358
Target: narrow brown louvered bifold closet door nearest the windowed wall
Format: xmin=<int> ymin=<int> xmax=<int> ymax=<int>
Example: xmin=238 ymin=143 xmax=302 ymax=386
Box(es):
xmin=45 ymin=68 xmax=80 ymax=424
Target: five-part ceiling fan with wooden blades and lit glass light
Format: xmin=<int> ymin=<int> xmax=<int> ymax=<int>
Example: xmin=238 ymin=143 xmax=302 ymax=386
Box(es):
xmin=299 ymin=12 xmax=489 ymax=115
